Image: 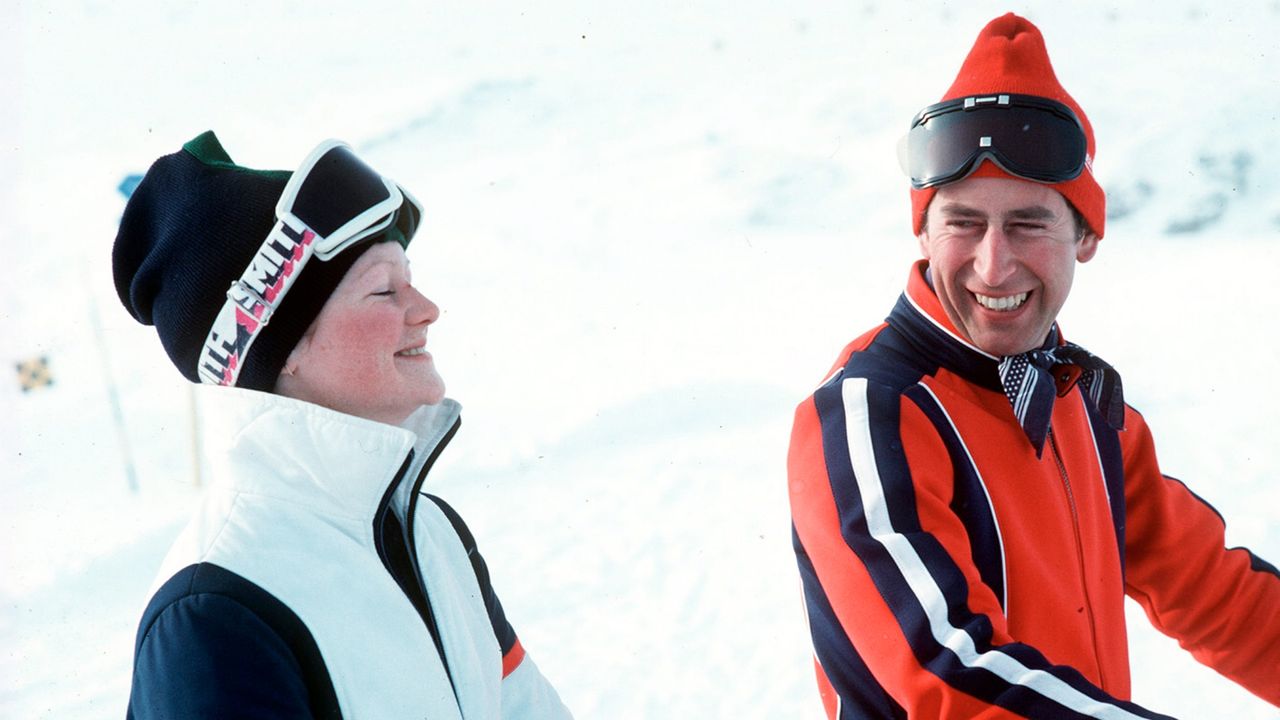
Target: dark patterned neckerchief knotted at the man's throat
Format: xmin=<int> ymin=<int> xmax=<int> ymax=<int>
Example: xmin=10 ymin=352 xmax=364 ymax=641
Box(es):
xmin=1000 ymin=342 xmax=1124 ymax=457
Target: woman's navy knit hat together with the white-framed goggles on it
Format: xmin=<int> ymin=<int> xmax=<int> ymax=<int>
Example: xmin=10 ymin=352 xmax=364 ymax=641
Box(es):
xmin=113 ymin=132 xmax=422 ymax=391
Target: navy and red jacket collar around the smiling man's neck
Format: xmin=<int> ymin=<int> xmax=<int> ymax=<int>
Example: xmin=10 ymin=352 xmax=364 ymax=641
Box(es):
xmin=887 ymin=260 xmax=1061 ymax=392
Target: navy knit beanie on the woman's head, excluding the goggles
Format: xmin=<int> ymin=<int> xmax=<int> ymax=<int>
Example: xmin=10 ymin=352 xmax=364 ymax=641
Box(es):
xmin=111 ymin=131 xmax=416 ymax=391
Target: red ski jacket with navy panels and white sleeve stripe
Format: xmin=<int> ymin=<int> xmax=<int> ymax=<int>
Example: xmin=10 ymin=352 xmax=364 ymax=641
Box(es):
xmin=787 ymin=261 xmax=1280 ymax=719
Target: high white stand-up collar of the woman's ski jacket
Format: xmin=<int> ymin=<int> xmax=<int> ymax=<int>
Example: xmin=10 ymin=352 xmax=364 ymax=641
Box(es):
xmin=197 ymin=386 xmax=461 ymax=521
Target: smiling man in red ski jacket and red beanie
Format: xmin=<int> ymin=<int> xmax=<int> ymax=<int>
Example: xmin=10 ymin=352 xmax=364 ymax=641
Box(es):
xmin=788 ymin=14 xmax=1280 ymax=719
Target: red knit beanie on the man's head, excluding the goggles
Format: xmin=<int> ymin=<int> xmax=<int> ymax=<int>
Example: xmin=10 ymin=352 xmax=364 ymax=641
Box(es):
xmin=911 ymin=13 xmax=1107 ymax=238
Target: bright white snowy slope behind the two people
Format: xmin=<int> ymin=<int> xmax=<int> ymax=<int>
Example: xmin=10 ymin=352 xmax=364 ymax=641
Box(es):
xmin=0 ymin=0 xmax=1280 ymax=719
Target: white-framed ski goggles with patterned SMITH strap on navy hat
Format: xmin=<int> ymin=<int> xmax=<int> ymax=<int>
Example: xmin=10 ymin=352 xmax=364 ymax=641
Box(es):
xmin=197 ymin=140 xmax=422 ymax=386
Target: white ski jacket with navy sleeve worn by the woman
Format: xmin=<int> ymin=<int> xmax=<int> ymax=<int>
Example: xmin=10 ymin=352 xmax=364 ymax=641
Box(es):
xmin=129 ymin=388 xmax=570 ymax=720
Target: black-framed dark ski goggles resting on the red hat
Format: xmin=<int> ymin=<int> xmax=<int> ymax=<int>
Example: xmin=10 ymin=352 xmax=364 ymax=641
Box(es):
xmin=899 ymin=95 xmax=1088 ymax=190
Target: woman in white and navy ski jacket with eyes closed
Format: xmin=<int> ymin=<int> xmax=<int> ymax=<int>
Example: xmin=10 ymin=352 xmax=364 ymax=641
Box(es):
xmin=113 ymin=132 xmax=570 ymax=720
